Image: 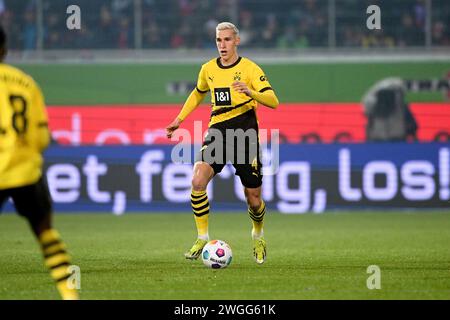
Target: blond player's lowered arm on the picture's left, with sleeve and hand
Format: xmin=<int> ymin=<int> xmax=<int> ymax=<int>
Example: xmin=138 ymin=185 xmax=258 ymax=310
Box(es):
xmin=166 ymin=67 xmax=209 ymax=139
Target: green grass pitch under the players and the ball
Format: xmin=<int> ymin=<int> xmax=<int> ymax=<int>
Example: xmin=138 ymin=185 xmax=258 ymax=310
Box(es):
xmin=0 ymin=210 xmax=450 ymax=300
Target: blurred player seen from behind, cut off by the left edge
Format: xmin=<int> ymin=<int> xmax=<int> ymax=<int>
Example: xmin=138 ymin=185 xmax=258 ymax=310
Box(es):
xmin=0 ymin=26 xmax=78 ymax=300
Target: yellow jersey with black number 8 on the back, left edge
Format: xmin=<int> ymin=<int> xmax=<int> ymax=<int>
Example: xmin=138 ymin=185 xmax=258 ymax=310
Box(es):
xmin=0 ymin=63 xmax=50 ymax=189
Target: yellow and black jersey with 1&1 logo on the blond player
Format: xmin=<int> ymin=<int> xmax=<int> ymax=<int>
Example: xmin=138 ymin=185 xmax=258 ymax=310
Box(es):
xmin=182 ymin=57 xmax=272 ymax=126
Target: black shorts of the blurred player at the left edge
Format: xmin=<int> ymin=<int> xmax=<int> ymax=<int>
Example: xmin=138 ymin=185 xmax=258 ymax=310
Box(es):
xmin=0 ymin=177 xmax=52 ymax=221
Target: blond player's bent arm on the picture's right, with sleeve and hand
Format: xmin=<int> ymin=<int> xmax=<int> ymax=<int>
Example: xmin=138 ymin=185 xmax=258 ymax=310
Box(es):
xmin=232 ymin=66 xmax=279 ymax=109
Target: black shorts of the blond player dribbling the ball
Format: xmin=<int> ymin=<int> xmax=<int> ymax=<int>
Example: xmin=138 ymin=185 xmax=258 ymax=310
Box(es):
xmin=195 ymin=109 xmax=262 ymax=188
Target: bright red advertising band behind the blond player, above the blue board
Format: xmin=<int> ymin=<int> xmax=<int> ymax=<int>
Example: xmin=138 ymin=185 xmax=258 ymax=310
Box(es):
xmin=48 ymin=103 xmax=450 ymax=144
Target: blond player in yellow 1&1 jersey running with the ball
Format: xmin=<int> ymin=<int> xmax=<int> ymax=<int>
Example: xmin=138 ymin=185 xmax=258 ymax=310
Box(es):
xmin=166 ymin=22 xmax=278 ymax=264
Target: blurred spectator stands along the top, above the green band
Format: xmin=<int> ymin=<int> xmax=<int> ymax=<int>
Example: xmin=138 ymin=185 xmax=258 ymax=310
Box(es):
xmin=0 ymin=0 xmax=450 ymax=50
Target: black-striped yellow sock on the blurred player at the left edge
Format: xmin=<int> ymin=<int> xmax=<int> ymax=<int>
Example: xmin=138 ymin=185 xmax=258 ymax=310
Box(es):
xmin=39 ymin=229 xmax=78 ymax=300
